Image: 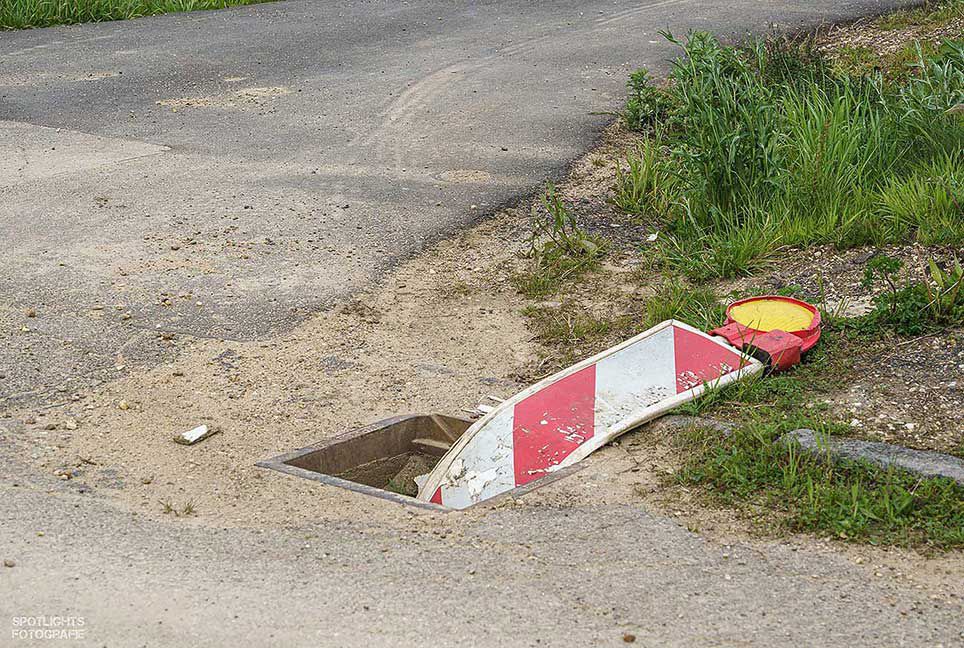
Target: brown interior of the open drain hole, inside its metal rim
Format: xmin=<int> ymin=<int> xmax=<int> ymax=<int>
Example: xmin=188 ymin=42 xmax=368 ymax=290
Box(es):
xmin=285 ymin=414 xmax=472 ymax=496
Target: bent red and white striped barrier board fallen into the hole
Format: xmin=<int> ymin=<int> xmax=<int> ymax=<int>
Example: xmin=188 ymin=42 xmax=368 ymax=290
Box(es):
xmin=418 ymin=320 xmax=763 ymax=509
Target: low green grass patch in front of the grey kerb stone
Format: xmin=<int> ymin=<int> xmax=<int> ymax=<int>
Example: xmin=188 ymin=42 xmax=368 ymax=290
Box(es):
xmin=679 ymin=424 xmax=964 ymax=550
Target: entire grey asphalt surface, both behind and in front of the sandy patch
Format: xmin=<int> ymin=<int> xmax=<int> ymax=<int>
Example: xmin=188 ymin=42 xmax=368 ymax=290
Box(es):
xmin=9 ymin=0 xmax=962 ymax=646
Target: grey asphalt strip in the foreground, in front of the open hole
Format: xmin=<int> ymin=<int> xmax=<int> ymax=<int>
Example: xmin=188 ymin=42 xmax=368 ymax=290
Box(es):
xmin=0 ymin=437 xmax=964 ymax=648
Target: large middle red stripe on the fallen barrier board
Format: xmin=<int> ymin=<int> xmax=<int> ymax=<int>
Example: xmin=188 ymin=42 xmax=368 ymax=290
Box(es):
xmin=512 ymin=365 xmax=596 ymax=486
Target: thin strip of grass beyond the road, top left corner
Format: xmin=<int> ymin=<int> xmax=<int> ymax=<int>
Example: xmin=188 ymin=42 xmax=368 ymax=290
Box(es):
xmin=0 ymin=0 xmax=265 ymax=29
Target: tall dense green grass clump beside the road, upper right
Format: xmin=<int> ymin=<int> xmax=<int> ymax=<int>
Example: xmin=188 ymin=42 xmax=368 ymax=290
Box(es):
xmin=615 ymin=33 xmax=964 ymax=278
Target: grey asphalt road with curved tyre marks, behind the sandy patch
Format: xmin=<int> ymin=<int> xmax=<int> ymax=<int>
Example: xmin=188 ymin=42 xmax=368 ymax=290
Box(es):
xmin=0 ymin=0 xmax=916 ymax=406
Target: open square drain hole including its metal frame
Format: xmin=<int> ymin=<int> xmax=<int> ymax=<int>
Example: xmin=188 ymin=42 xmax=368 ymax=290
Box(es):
xmin=257 ymin=414 xmax=581 ymax=511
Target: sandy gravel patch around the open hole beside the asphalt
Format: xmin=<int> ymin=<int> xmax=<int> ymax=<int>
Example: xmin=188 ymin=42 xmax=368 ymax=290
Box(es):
xmin=11 ymin=215 xmax=533 ymax=524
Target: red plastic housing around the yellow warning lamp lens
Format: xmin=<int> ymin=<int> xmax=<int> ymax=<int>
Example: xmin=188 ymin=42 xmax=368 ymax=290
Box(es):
xmin=710 ymin=295 xmax=820 ymax=371
